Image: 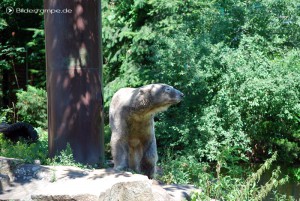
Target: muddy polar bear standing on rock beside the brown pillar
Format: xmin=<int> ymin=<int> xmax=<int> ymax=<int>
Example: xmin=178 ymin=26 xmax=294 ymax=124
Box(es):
xmin=109 ymin=84 xmax=184 ymax=179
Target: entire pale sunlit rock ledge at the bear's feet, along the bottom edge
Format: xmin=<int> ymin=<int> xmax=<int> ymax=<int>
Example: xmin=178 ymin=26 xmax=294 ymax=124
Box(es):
xmin=0 ymin=158 xmax=198 ymax=201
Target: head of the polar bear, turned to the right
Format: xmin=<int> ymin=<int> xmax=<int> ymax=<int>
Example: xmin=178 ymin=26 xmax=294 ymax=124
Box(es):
xmin=138 ymin=84 xmax=184 ymax=115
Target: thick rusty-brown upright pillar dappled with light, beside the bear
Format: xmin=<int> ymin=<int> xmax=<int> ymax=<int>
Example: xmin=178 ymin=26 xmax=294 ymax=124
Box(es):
xmin=44 ymin=0 xmax=104 ymax=164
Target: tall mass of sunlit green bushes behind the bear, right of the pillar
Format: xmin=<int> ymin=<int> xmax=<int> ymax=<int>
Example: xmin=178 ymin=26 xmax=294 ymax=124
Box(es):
xmin=103 ymin=0 xmax=300 ymax=164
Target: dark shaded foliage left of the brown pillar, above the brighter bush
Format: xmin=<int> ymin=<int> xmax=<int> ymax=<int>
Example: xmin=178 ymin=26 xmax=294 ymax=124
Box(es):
xmin=0 ymin=0 xmax=46 ymax=107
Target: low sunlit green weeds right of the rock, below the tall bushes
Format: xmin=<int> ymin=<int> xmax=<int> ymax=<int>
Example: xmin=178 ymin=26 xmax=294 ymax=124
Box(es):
xmin=160 ymin=153 xmax=288 ymax=201
